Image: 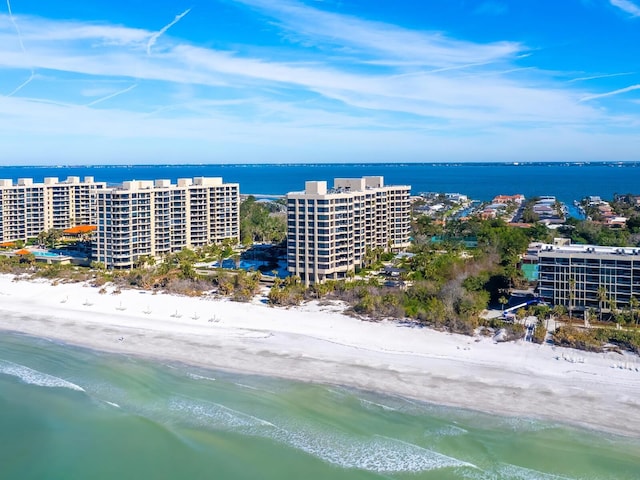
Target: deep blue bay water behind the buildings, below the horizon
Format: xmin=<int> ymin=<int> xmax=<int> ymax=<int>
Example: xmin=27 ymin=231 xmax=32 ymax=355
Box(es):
xmin=0 ymin=163 xmax=640 ymax=203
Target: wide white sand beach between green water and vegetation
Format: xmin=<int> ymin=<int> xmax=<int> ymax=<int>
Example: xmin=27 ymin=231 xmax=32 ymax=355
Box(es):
xmin=0 ymin=275 xmax=640 ymax=436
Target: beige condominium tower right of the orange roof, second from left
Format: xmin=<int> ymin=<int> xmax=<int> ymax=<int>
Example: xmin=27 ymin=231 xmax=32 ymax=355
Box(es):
xmin=93 ymin=177 xmax=240 ymax=268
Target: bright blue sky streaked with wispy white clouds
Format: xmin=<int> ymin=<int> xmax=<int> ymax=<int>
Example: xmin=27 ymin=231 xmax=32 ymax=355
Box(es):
xmin=0 ymin=0 xmax=640 ymax=165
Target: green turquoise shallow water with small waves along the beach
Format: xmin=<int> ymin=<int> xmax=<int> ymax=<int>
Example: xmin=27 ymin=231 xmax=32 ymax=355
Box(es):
xmin=0 ymin=333 xmax=640 ymax=480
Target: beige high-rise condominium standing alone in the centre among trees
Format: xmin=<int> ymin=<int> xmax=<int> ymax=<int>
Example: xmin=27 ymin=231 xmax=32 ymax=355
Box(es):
xmin=287 ymin=177 xmax=411 ymax=285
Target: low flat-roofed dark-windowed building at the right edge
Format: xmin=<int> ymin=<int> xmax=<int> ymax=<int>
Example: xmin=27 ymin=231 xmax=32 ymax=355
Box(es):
xmin=537 ymin=242 xmax=640 ymax=311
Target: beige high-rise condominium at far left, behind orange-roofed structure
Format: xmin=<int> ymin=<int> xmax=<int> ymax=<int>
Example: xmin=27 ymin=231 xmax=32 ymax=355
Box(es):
xmin=0 ymin=177 xmax=106 ymax=242
